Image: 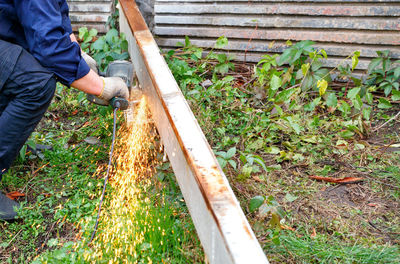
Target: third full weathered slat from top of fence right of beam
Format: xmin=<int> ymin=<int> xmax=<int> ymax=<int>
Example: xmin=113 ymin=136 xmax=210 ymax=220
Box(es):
xmin=154 ymin=26 xmax=400 ymax=46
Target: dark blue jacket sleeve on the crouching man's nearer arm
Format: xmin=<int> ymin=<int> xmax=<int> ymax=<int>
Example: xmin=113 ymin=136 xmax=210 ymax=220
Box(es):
xmin=14 ymin=0 xmax=90 ymax=86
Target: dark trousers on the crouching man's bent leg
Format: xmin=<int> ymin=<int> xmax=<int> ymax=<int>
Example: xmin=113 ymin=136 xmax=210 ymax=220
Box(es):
xmin=0 ymin=40 xmax=56 ymax=180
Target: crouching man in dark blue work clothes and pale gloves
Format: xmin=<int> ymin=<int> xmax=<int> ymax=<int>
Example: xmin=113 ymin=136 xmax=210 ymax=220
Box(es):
xmin=0 ymin=0 xmax=128 ymax=220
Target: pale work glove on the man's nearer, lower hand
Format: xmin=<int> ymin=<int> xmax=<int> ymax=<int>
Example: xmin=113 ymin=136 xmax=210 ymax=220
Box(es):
xmin=98 ymin=77 xmax=129 ymax=102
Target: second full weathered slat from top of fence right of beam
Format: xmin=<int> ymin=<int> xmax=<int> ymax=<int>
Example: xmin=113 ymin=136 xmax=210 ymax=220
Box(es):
xmin=154 ymin=15 xmax=400 ymax=30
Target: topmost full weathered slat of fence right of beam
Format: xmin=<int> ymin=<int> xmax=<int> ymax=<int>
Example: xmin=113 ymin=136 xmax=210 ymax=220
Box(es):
xmin=154 ymin=1 xmax=400 ymax=17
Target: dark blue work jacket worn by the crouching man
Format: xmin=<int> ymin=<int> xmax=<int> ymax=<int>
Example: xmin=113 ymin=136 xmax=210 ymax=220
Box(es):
xmin=0 ymin=0 xmax=90 ymax=86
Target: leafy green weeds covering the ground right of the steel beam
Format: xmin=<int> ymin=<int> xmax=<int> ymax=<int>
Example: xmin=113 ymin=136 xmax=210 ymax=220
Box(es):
xmin=166 ymin=37 xmax=399 ymax=263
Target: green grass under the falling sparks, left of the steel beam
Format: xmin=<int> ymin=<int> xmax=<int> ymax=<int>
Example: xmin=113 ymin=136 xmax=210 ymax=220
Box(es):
xmin=0 ymin=86 xmax=203 ymax=263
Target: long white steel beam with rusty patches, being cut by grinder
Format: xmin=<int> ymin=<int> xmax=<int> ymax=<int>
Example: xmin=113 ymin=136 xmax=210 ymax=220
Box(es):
xmin=120 ymin=0 xmax=268 ymax=264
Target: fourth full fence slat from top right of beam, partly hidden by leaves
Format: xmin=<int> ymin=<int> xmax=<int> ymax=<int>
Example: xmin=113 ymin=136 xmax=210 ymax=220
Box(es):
xmin=157 ymin=37 xmax=400 ymax=59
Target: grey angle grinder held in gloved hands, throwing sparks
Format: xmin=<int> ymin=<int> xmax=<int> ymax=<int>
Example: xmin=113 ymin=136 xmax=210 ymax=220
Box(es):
xmin=86 ymin=60 xmax=141 ymax=115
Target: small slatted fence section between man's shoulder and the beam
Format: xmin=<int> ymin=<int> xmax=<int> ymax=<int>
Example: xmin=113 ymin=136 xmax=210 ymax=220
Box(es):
xmin=67 ymin=0 xmax=115 ymax=33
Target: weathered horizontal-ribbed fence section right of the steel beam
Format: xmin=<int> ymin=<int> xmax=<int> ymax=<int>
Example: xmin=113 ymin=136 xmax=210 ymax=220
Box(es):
xmin=154 ymin=0 xmax=400 ymax=69
